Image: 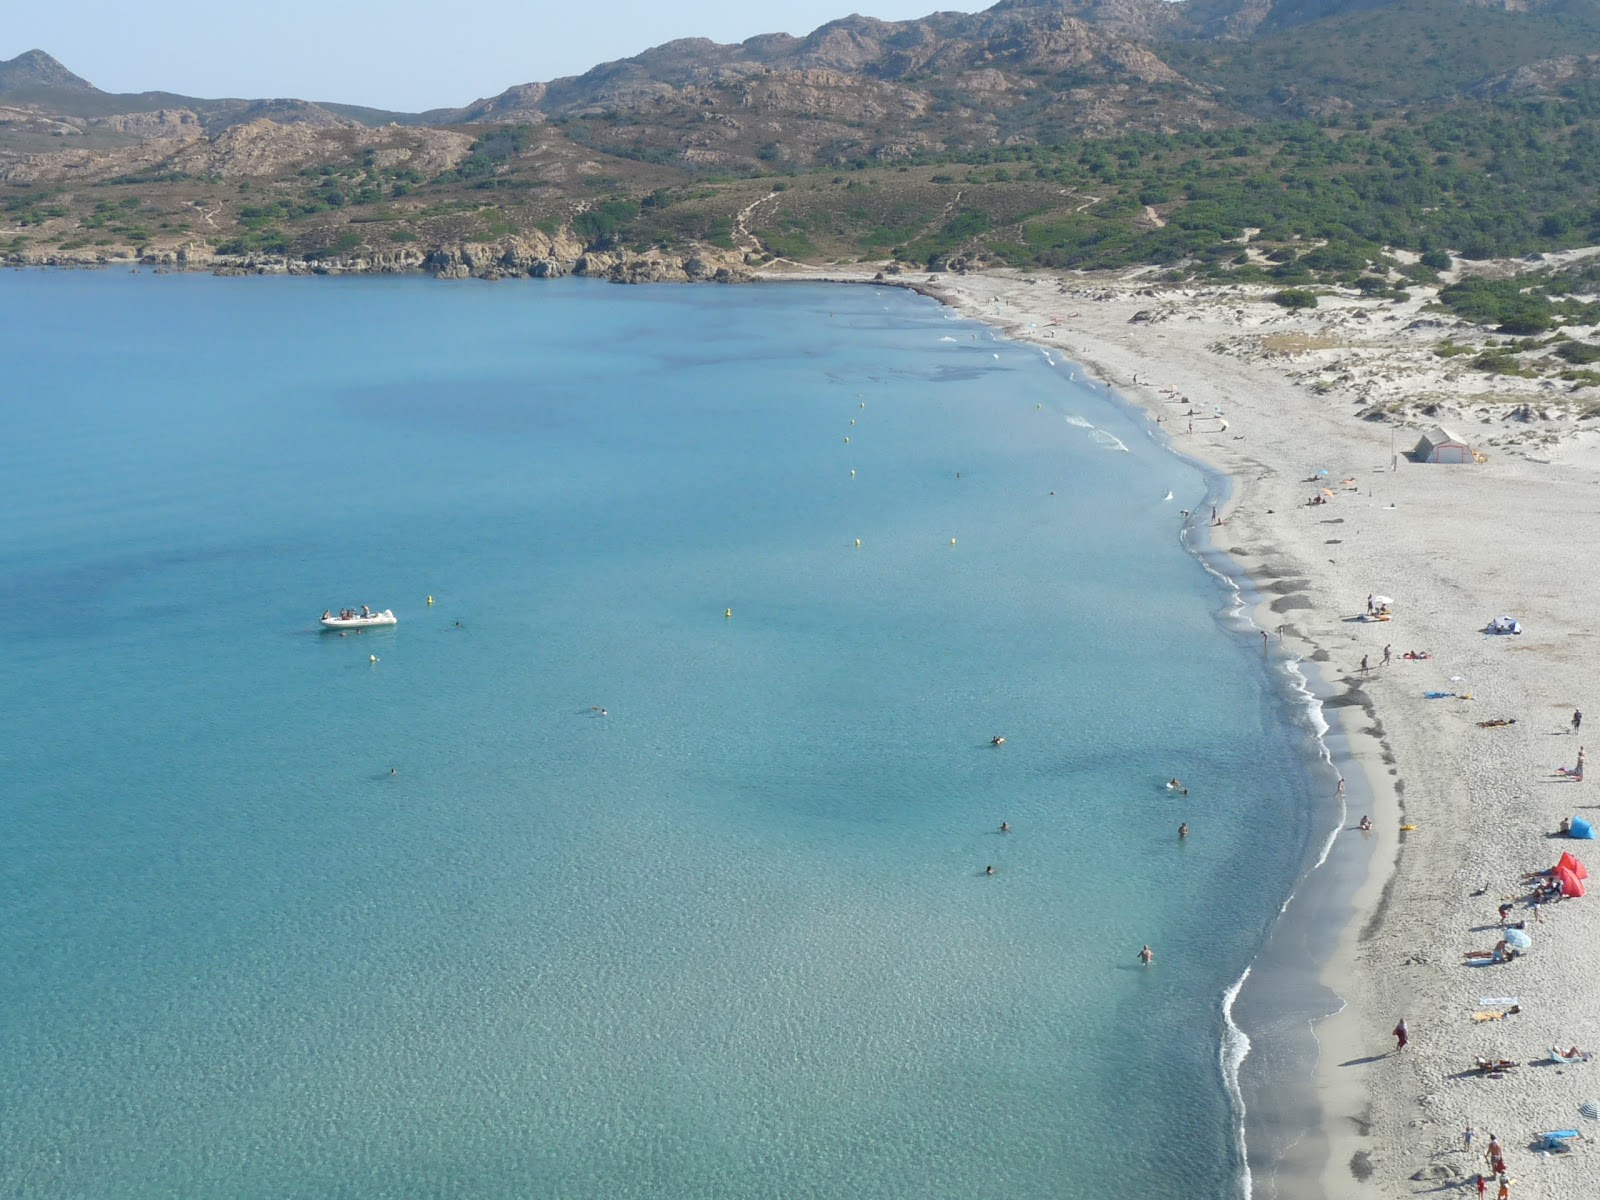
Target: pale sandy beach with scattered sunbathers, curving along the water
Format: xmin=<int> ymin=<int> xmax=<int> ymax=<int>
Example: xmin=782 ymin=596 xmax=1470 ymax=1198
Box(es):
xmin=770 ymin=270 xmax=1600 ymax=1200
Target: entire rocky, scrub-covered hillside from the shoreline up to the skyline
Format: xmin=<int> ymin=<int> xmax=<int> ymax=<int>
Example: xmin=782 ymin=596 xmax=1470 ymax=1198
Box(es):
xmin=0 ymin=0 xmax=1600 ymax=286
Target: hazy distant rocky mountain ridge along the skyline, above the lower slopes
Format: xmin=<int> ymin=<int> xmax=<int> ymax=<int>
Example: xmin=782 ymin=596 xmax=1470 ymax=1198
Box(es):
xmin=9 ymin=0 xmax=1600 ymax=144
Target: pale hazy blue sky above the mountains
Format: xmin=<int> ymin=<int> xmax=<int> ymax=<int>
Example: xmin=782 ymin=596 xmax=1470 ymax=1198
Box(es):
xmin=9 ymin=0 xmax=992 ymax=112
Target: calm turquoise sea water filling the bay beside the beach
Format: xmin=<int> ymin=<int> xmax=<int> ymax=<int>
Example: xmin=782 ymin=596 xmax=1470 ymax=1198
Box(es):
xmin=0 ymin=274 xmax=1314 ymax=1200
